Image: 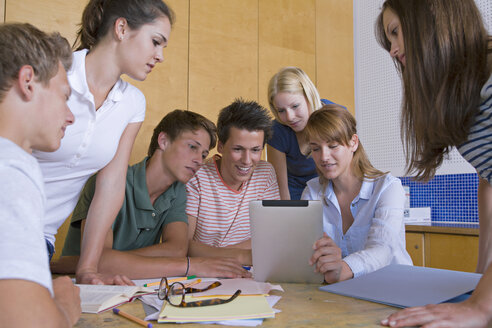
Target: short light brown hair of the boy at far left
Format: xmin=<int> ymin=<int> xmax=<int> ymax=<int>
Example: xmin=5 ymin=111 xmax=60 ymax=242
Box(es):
xmin=0 ymin=23 xmax=72 ymax=101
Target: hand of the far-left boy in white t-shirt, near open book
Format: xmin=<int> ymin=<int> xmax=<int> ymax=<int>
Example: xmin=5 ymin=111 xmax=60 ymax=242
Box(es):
xmin=53 ymin=276 xmax=82 ymax=326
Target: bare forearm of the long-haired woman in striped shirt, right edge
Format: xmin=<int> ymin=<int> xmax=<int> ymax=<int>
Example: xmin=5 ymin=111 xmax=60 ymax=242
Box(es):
xmin=477 ymin=179 xmax=492 ymax=272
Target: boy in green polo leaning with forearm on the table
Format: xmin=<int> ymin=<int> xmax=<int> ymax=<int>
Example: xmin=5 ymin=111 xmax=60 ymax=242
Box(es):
xmin=55 ymin=110 xmax=249 ymax=279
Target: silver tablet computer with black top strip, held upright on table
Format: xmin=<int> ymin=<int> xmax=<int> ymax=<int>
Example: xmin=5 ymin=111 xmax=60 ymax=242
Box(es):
xmin=249 ymin=200 xmax=323 ymax=284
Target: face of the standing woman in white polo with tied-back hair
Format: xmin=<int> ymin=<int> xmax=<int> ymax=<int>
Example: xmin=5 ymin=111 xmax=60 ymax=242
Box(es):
xmin=119 ymin=16 xmax=171 ymax=81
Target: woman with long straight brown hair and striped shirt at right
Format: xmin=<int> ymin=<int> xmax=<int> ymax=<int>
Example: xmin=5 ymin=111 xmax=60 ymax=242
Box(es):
xmin=376 ymin=0 xmax=492 ymax=327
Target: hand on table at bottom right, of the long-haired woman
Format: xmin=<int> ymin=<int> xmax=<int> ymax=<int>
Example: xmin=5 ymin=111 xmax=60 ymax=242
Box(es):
xmin=381 ymin=300 xmax=488 ymax=328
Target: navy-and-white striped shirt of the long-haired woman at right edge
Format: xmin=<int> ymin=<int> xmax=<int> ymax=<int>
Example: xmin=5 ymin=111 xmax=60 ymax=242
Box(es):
xmin=458 ymin=75 xmax=492 ymax=184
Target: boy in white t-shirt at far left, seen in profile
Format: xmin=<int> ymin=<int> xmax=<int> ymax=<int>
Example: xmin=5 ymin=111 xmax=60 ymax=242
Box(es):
xmin=0 ymin=23 xmax=81 ymax=327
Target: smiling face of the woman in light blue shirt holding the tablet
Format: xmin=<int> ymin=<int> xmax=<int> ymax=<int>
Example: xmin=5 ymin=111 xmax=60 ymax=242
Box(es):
xmin=309 ymin=134 xmax=359 ymax=180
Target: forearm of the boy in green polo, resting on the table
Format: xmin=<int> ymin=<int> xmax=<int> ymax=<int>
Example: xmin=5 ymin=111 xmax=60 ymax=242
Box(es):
xmin=98 ymin=249 xmax=188 ymax=279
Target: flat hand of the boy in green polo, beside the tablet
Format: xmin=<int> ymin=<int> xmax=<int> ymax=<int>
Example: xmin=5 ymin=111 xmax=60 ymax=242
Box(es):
xmin=189 ymin=257 xmax=251 ymax=278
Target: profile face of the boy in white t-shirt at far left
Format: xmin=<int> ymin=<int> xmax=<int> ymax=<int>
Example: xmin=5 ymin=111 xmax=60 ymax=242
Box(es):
xmin=31 ymin=62 xmax=74 ymax=151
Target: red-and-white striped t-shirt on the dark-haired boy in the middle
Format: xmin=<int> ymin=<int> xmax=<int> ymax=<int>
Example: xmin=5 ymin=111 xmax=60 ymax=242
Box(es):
xmin=186 ymin=155 xmax=280 ymax=247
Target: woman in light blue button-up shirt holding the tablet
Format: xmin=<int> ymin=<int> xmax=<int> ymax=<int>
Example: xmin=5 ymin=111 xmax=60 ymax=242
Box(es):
xmin=302 ymin=104 xmax=412 ymax=283
